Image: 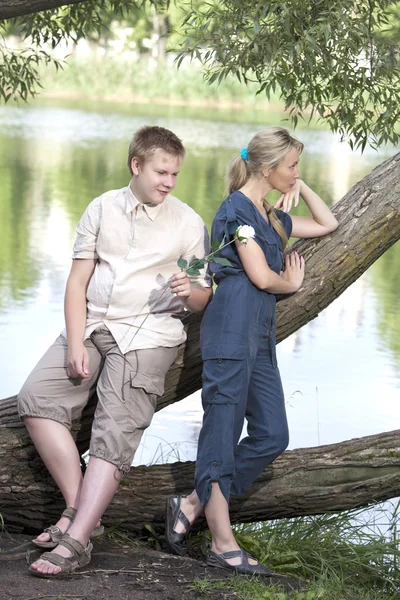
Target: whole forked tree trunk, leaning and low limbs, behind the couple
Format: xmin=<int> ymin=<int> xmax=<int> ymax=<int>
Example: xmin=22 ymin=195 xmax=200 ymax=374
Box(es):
xmin=0 ymin=154 xmax=400 ymax=530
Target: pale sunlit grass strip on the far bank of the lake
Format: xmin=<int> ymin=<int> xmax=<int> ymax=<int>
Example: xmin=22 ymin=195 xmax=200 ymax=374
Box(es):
xmin=36 ymin=56 xmax=282 ymax=109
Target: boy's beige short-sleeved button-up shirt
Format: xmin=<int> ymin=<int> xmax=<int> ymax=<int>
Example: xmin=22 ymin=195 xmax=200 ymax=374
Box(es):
xmin=64 ymin=186 xmax=211 ymax=353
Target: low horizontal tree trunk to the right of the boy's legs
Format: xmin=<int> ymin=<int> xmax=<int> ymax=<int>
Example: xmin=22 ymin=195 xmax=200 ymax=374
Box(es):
xmin=80 ymin=430 xmax=400 ymax=531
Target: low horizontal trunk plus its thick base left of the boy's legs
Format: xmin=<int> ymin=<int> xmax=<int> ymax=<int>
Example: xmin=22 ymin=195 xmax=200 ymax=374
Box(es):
xmin=0 ymin=398 xmax=400 ymax=533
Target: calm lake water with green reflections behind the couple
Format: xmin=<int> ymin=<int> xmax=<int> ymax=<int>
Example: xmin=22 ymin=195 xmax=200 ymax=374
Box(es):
xmin=0 ymin=100 xmax=400 ymax=464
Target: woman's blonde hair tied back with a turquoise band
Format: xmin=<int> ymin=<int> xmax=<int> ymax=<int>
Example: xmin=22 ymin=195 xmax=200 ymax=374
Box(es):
xmin=227 ymin=127 xmax=304 ymax=248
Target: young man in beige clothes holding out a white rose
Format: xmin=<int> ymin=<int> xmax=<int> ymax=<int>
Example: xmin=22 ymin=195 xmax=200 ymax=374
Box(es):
xmin=18 ymin=127 xmax=211 ymax=577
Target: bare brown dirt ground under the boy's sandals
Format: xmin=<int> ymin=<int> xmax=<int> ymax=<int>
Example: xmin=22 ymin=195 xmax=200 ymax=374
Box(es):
xmin=0 ymin=532 xmax=299 ymax=600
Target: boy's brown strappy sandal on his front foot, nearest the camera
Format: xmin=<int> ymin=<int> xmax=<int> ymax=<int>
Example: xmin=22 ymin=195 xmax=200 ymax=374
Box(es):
xmin=29 ymin=533 xmax=93 ymax=579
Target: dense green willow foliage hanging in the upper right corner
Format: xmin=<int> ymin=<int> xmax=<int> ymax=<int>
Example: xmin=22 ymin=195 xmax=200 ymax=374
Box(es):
xmin=178 ymin=0 xmax=400 ymax=149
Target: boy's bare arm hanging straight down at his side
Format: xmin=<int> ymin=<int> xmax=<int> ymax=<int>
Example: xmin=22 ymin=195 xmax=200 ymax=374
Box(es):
xmin=64 ymin=259 xmax=97 ymax=378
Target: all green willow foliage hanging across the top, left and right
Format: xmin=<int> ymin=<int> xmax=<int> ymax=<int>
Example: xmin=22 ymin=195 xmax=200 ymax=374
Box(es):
xmin=0 ymin=0 xmax=400 ymax=149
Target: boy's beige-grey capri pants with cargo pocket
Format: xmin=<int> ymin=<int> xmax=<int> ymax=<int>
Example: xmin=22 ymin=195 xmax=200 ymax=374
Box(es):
xmin=18 ymin=326 xmax=178 ymax=472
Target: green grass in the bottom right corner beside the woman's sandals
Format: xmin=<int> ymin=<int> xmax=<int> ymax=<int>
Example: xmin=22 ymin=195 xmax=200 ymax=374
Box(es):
xmin=186 ymin=503 xmax=400 ymax=600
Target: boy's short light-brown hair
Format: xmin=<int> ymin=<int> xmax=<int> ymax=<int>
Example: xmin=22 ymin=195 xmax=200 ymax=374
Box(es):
xmin=128 ymin=125 xmax=185 ymax=175
